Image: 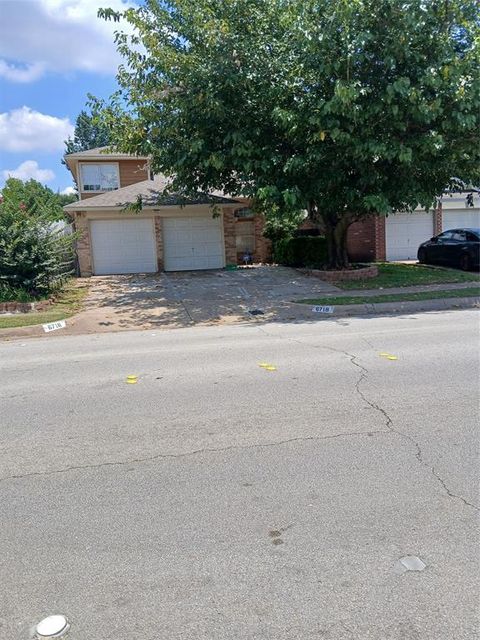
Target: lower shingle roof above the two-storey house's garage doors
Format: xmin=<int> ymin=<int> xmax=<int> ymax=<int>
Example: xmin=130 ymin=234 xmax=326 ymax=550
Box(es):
xmin=64 ymin=176 xmax=242 ymax=211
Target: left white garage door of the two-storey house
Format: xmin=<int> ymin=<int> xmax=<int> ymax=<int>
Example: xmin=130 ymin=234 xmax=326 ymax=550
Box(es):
xmin=90 ymin=218 xmax=157 ymax=275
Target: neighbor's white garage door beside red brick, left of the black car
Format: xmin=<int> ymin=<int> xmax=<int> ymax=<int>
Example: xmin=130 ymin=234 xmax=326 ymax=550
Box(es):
xmin=385 ymin=211 xmax=433 ymax=260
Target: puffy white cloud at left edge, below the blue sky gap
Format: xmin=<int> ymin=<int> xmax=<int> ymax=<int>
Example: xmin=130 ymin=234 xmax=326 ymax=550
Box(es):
xmin=0 ymin=106 xmax=74 ymax=152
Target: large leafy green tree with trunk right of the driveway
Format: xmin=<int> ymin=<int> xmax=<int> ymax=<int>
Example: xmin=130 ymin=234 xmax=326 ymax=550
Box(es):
xmin=95 ymin=0 xmax=480 ymax=268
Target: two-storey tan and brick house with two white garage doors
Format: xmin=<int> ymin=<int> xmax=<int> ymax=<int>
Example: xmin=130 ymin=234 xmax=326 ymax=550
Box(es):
xmin=64 ymin=148 xmax=270 ymax=276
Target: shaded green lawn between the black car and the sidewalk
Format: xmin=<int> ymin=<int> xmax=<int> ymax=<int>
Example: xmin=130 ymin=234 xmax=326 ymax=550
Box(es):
xmin=335 ymin=262 xmax=479 ymax=289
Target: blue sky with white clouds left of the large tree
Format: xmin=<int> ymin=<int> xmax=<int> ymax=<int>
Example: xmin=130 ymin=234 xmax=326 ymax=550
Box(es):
xmin=0 ymin=0 xmax=135 ymax=191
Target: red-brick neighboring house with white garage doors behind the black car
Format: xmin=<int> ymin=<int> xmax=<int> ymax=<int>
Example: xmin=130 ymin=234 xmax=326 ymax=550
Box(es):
xmin=347 ymin=189 xmax=480 ymax=262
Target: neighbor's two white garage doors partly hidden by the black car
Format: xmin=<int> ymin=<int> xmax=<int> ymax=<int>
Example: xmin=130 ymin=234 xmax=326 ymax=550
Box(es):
xmin=385 ymin=208 xmax=480 ymax=260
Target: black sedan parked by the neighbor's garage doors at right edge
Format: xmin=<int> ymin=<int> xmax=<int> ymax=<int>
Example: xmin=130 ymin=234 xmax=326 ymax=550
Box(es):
xmin=417 ymin=229 xmax=480 ymax=271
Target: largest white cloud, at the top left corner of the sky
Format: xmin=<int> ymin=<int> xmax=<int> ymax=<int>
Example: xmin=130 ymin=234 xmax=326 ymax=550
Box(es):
xmin=0 ymin=0 xmax=136 ymax=82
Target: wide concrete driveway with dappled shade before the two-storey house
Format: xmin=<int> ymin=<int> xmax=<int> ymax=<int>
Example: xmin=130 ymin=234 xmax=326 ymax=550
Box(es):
xmin=67 ymin=266 xmax=338 ymax=333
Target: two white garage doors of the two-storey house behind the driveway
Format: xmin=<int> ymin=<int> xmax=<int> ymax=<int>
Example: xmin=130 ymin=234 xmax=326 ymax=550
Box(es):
xmin=90 ymin=215 xmax=225 ymax=275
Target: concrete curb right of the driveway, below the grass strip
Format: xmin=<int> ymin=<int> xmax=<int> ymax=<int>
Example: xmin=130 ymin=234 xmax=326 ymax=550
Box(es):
xmin=292 ymin=296 xmax=480 ymax=318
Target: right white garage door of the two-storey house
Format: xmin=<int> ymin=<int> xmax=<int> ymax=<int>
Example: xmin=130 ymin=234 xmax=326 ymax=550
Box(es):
xmin=163 ymin=215 xmax=225 ymax=271
